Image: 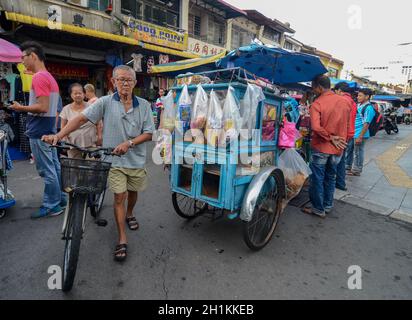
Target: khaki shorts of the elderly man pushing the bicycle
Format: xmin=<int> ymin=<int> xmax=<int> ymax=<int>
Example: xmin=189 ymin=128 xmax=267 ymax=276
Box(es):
xmin=109 ymin=168 xmax=147 ymax=194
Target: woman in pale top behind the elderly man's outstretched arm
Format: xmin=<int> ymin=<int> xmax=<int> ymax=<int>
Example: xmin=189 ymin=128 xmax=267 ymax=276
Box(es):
xmin=60 ymin=83 xmax=101 ymax=159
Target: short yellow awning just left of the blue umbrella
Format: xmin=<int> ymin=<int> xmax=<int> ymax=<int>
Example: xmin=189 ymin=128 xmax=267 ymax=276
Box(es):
xmin=152 ymin=51 xmax=226 ymax=76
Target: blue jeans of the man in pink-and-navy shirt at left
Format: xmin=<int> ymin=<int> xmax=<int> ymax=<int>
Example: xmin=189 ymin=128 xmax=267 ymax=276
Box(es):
xmin=30 ymin=139 xmax=66 ymax=209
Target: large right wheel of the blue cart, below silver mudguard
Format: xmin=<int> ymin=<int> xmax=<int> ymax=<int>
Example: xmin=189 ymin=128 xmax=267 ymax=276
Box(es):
xmin=243 ymin=177 xmax=282 ymax=251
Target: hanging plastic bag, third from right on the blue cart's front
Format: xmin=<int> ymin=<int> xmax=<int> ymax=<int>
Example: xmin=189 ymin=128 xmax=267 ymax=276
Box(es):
xmin=205 ymin=90 xmax=223 ymax=147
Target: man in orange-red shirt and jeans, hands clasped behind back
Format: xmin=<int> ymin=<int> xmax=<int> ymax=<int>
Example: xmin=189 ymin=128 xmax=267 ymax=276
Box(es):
xmin=302 ymin=75 xmax=351 ymax=218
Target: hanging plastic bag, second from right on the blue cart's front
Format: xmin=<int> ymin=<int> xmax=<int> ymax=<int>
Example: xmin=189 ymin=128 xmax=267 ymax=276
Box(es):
xmin=222 ymin=86 xmax=242 ymax=142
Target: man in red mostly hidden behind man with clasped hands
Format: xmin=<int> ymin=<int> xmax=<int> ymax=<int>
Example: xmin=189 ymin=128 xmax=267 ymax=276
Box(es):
xmin=335 ymin=82 xmax=358 ymax=191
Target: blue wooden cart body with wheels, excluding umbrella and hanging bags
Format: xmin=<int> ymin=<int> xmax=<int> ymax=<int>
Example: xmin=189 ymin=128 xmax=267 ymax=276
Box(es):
xmin=171 ymin=68 xmax=286 ymax=250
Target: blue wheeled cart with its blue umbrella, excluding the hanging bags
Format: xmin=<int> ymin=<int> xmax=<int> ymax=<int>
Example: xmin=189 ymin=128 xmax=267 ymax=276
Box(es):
xmin=159 ymin=44 xmax=327 ymax=251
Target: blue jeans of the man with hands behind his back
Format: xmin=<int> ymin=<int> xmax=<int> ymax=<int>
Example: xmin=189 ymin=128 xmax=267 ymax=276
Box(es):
xmin=309 ymin=149 xmax=341 ymax=213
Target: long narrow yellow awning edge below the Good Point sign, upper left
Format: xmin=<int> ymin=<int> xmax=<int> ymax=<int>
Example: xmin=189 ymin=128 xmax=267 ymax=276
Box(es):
xmin=6 ymin=12 xmax=199 ymax=59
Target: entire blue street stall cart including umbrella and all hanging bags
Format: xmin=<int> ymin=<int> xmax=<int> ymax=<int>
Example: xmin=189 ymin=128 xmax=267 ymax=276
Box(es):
xmin=155 ymin=44 xmax=327 ymax=250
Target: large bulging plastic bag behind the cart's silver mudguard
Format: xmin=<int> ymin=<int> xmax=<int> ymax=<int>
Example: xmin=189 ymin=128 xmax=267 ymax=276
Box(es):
xmin=279 ymin=149 xmax=312 ymax=201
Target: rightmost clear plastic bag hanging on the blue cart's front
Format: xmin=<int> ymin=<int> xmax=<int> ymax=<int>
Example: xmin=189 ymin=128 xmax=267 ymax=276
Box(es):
xmin=240 ymin=83 xmax=265 ymax=139
